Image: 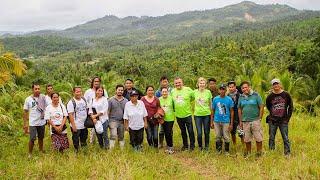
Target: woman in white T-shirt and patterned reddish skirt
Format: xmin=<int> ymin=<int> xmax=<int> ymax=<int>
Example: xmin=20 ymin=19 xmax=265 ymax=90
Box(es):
xmin=45 ymin=93 xmax=69 ymax=152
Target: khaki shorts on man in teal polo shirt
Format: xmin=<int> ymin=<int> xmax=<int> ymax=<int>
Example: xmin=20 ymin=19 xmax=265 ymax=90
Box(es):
xmin=242 ymin=120 xmax=263 ymax=142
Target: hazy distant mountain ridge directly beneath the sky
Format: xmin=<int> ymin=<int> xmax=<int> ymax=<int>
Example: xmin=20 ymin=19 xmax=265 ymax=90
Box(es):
xmin=33 ymin=1 xmax=304 ymax=38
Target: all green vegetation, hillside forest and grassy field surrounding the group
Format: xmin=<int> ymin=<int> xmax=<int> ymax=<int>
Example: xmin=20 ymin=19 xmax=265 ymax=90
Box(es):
xmin=0 ymin=2 xmax=320 ymax=179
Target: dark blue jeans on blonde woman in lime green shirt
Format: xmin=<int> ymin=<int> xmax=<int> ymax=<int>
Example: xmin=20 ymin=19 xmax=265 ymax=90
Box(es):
xmin=194 ymin=116 xmax=210 ymax=148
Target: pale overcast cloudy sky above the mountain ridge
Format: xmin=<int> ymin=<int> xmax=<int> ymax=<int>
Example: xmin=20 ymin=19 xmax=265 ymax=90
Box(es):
xmin=0 ymin=0 xmax=320 ymax=31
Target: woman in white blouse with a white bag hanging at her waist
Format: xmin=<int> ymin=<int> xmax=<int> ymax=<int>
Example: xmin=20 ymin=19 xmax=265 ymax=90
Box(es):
xmin=89 ymin=86 xmax=109 ymax=149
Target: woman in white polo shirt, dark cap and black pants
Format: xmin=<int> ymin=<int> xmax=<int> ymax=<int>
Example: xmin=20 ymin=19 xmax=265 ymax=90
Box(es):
xmin=123 ymin=90 xmax=148 ymax=151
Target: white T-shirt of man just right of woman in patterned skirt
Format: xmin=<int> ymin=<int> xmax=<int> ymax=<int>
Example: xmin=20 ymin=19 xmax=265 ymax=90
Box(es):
xmin=67 ymin=98 xmax=88 ymax=129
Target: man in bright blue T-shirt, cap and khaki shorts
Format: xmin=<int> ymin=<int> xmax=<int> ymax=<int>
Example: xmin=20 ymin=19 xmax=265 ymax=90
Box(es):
xmin=211 ymin=84 xmax=234 ymax=154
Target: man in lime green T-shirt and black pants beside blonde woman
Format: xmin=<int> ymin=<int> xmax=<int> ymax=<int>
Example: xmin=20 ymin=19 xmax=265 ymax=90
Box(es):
xmin=171 ymin=77 xmax=195 ymax=151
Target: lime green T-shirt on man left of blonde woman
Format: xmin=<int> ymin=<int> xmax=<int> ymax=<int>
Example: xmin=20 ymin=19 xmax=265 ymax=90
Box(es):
xmin=171 ymin=86 xmax=194 ymax=118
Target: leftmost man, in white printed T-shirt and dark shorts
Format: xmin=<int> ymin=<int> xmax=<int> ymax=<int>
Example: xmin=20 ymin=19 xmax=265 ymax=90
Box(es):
xmin=23 ymin=83 xmax=46 ymax=157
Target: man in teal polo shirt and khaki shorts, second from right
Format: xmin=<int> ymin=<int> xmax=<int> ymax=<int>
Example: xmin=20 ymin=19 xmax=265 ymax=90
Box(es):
xmin=238 ymin=81 xmax=263 ymax=156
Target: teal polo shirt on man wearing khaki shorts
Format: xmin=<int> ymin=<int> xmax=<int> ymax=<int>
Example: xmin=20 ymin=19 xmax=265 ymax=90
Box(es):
xmin=238 ymin=92 xmax=262 ymax=121
